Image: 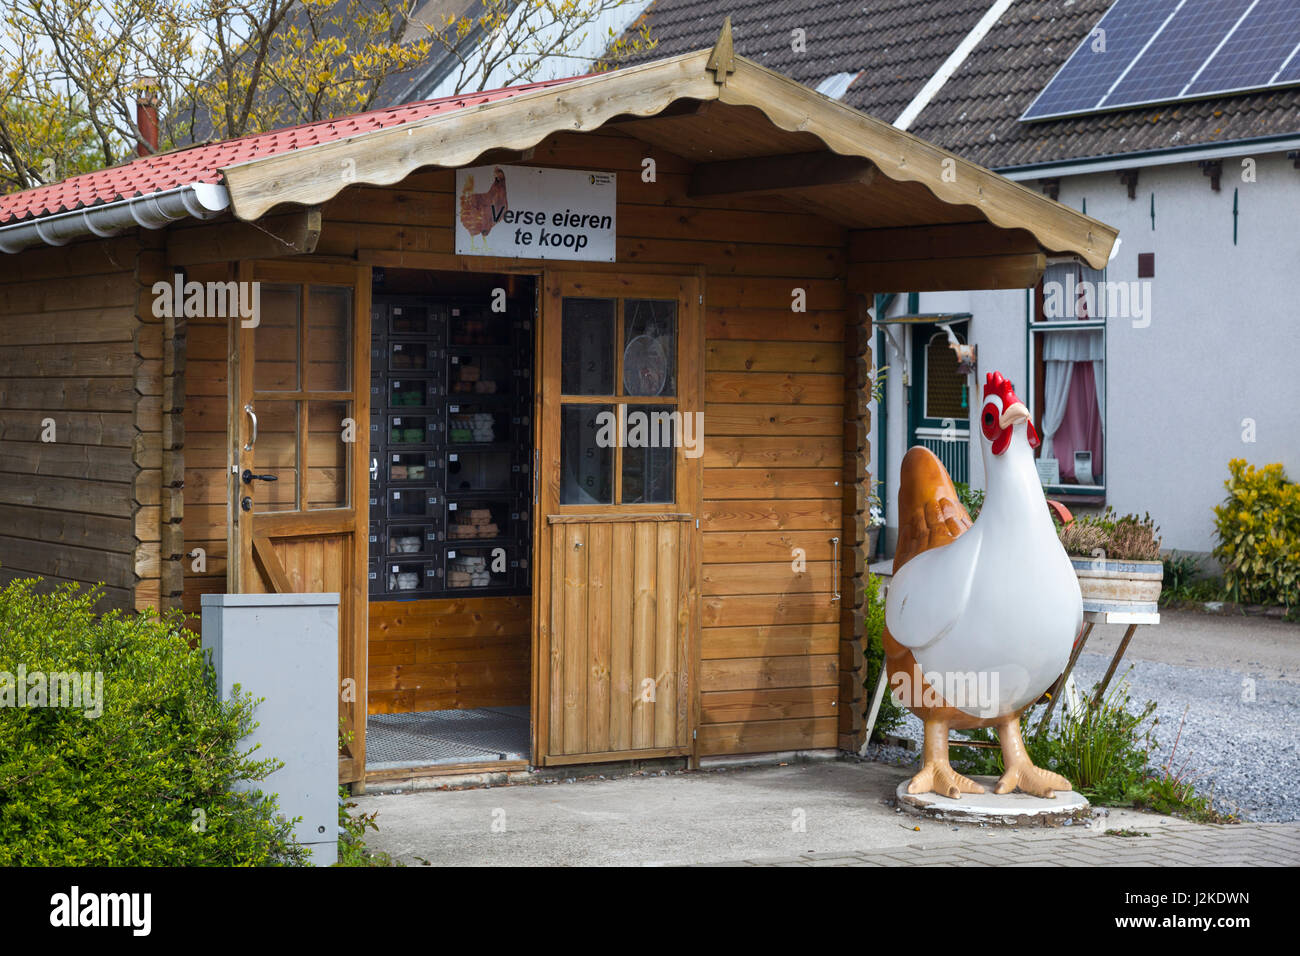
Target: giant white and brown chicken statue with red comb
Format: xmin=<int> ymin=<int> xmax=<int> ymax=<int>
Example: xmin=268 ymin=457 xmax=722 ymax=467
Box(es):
xmin=884 ymin=372 xmax=1083 ymax=797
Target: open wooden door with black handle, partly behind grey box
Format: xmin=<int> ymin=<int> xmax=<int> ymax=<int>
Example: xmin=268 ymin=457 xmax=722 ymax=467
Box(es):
xmin=228 ymin=263 xmax=371 ymax=783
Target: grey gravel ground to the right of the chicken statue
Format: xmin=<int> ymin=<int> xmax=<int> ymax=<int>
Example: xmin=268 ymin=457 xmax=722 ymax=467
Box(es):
xmin=867 ymin=653 xmax=1300 ymax=822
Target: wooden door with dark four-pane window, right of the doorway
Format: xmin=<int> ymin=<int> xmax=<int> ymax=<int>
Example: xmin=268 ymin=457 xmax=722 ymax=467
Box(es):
xmin=533 ymin=273 xmax=703 ymax=765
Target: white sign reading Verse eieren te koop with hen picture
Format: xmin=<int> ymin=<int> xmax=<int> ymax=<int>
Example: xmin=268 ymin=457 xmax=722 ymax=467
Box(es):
xmin=455 ymin=166 xmax=618 ymax=263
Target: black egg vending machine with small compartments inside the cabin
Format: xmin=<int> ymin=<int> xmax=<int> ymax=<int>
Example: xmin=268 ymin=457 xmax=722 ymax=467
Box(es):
xmin=369 ymin=295 xmax=533 ymax=600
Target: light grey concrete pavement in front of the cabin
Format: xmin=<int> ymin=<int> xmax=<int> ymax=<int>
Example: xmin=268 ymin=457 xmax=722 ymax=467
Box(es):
xmin=354 ymin=760 xmax=1300 ymax=866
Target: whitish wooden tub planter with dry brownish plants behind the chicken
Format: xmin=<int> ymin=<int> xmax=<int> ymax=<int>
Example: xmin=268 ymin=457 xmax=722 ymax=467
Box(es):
xmin=1057 ymin=509 xmax=1165 ymax=614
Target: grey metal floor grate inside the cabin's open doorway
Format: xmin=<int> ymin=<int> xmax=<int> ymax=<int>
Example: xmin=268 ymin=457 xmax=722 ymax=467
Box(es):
xmin=365 ymin=708 xmax=529 ymax=770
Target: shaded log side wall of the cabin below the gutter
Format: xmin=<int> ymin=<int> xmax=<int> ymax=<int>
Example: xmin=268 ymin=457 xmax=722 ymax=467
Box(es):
xmin=0 ymin=233 xmax=171 ymax=609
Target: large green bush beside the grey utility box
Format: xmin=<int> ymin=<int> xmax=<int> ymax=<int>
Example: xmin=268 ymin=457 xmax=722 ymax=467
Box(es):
xmin=0 ymin=580 xmax=306 ymax=866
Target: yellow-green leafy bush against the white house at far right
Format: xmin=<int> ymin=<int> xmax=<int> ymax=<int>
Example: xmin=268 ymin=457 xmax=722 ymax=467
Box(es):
xmin=1214 ymin=458 xmax=1300 ymax=607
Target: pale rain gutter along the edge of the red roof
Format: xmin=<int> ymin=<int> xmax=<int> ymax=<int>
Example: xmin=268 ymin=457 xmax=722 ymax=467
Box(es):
xmin=0 ymin=182 xmax=230 ymax=254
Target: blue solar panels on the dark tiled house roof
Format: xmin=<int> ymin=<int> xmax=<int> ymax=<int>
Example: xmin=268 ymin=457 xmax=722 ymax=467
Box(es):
xmin=1021 ymin=0 xmax=1300 ymax=120
